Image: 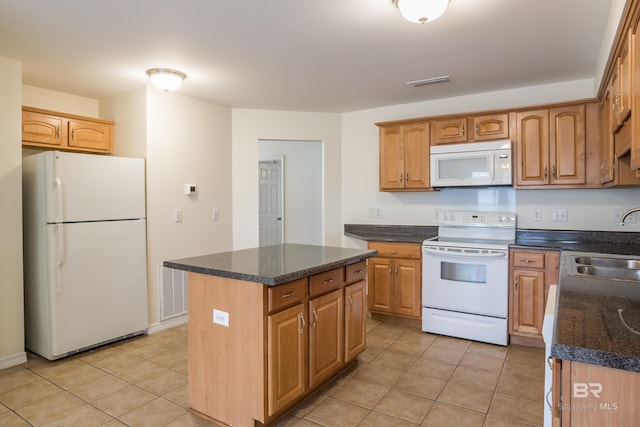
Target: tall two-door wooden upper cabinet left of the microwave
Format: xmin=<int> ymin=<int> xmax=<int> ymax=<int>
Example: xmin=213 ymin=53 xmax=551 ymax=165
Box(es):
xmin=380 ymin=122 xmax=429 ymax=191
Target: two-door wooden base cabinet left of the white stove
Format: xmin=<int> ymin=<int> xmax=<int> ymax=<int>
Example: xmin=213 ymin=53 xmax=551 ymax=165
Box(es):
xmin=368 ymin=242 xmax=422 ymax=319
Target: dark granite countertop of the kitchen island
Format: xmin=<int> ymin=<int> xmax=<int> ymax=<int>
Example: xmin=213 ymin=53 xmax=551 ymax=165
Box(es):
xmin=163 ymin=243 xmax=378 ymax=285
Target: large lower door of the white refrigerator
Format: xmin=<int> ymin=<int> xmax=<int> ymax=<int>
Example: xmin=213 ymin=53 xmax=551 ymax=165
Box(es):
xmin=43 ymin=220 xmax=148 ymax=359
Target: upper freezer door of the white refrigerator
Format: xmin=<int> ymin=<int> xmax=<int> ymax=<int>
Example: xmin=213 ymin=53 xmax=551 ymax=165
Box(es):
xmin=42 ymin=151 xmax=145 ymax=223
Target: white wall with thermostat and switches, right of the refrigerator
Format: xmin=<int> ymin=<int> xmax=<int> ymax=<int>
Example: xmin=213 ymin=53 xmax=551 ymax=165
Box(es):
xmin=146 ymin=87 xmax=234 ymax=325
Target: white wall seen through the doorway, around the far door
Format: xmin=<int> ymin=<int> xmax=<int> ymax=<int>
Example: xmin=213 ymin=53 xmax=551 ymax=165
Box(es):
xmin=258 ymin=141 xmax=324 ymax=245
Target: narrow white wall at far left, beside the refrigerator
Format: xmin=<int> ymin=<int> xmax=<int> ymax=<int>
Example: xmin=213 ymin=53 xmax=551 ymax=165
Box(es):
xmin=0 ymin=58 xmax=27 ymax=369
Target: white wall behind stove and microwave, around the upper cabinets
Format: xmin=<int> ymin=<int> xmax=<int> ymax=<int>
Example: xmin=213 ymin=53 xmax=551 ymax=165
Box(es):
xmin=342 ymin=80 xmax=640 ymax=247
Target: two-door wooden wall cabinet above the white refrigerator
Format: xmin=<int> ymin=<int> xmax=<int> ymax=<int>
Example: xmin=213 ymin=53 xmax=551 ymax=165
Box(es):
xmin=22 ymin=107 xmax=114 ymax=154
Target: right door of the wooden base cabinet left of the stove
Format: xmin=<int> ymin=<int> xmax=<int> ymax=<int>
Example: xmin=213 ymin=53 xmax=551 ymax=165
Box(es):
xmin=393 ymin=259 xmax=422 ymax=317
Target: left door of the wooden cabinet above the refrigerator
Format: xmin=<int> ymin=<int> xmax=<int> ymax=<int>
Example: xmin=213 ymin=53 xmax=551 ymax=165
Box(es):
xmin=22 ymin=111 xmax=67 ymax=147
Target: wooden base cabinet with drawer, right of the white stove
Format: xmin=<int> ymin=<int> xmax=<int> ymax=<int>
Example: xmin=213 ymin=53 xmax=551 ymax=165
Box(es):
xmin=509 ymin=249 xmax=560 ymax=346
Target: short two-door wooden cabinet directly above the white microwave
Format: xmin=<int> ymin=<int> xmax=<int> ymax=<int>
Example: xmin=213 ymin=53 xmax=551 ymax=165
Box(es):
xmin=431 ymin=113 xmax=509 ymax=145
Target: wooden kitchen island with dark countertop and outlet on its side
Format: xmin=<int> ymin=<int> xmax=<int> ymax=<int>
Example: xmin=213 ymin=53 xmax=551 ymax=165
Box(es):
xmin=164 ymin=244 xmax=377 ymax=426
